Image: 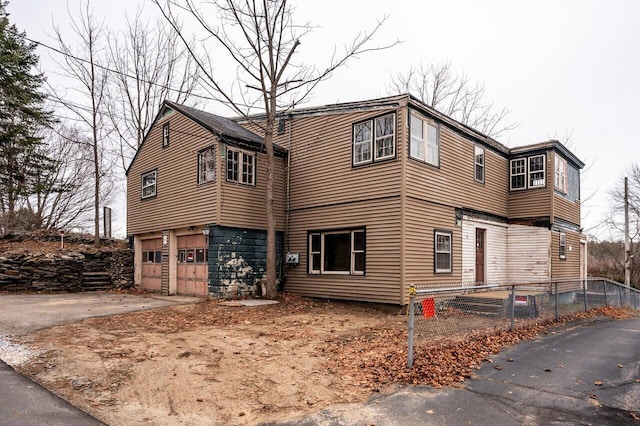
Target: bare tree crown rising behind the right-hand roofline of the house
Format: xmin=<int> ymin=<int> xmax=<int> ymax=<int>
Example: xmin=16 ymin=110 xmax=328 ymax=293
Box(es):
xmin=387 ymin=62 xmax=517 ymax=138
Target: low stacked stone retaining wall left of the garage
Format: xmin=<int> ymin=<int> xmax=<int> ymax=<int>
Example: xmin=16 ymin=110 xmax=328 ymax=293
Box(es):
xmin=0 ymin=249 xmax=133 ymax=292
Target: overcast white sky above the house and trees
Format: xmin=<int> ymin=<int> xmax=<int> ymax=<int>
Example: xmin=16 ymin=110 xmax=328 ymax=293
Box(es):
xmin=8 ymin=0 xmax=640 ymax=238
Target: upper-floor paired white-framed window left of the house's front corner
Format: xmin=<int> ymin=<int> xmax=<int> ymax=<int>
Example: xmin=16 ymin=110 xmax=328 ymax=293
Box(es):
xmin=353 ymin=114 xmax=396 ymax=165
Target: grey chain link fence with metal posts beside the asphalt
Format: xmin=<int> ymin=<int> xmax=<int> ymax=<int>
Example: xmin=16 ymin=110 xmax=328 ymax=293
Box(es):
xmin=407 ymin=278 xmax=640 ymax=367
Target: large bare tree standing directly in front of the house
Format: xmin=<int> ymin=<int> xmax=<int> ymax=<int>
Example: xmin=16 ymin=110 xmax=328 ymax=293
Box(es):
xmin=153 ymin=0 xmax=395 ymax=299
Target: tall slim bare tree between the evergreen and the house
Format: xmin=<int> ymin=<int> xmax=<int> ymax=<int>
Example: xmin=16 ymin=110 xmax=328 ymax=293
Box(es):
xmin=50 ymin=2 xmax=112 ymax=246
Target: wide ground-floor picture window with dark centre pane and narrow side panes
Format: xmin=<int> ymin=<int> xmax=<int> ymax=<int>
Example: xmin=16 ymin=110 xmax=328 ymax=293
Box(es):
xmin=308 ymin=229 xmax=366 ymax=275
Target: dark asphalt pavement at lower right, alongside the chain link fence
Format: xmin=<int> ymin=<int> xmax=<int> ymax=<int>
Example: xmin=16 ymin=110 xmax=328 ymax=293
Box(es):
xmin=282 ymin=319 xmax=640 ymax=426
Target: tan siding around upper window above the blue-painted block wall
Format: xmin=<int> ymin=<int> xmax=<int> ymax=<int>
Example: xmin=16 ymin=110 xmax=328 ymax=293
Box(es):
xmin=220 ymin=148 xmax=285 ymax=231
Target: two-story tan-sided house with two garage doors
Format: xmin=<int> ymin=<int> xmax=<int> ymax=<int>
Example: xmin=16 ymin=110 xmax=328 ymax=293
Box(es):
xmin=128 ymin=95 xmax=586 ymax=304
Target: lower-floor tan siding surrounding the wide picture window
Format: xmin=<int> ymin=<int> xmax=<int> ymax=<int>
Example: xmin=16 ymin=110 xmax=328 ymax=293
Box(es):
xmin=285 ymin=197 xmax=401 ymax=304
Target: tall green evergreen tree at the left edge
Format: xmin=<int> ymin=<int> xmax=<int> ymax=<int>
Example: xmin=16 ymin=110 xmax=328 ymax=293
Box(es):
xmin=0 ymin=0 xmax=53 ymax=229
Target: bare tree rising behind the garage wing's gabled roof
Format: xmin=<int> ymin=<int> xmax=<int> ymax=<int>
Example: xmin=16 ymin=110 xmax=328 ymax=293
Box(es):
xmin=109 ymin=10 xmax=198 ymax=170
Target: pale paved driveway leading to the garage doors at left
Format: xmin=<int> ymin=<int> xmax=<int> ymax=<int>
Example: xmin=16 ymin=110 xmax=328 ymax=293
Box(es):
xmin=0 ymin=291 xmax=202 ymax=336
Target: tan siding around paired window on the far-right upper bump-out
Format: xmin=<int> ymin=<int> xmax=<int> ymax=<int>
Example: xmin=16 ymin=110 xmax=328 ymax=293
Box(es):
xmin=506 ymin=152 xmax=554 ymax=219
